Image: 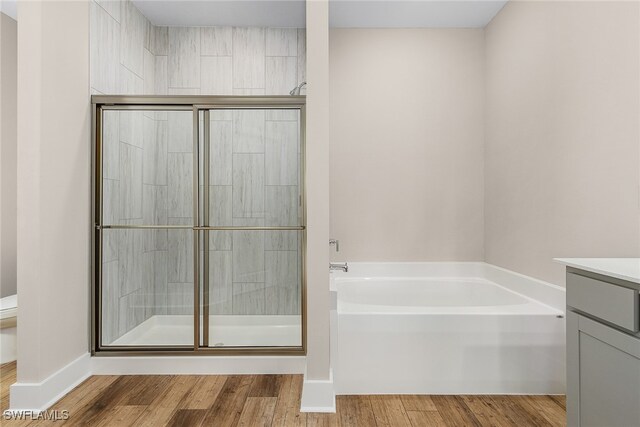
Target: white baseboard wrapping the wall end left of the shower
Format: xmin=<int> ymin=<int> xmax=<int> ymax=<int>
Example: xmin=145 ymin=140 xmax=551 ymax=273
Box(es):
xmin=10 ymin=353 xmax=91 ymax=412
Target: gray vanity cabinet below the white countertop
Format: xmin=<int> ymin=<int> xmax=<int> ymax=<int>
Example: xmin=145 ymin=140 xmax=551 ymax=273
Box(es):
xmin=567 ymin=269 xmax=640 ymax=427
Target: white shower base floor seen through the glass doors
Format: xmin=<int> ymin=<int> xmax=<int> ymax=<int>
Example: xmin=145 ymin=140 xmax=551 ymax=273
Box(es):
xmin=109 ymin=315 xmax=302 ymax=347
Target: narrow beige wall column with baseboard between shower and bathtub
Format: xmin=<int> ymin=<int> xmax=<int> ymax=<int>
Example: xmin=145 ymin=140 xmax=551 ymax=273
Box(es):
xmin=302 ymin=0 xmax=335 ymax=411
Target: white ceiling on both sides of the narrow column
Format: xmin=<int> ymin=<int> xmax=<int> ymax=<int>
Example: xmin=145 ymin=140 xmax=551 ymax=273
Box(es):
xmin=133 ymin=0 xmax=507 ymax=28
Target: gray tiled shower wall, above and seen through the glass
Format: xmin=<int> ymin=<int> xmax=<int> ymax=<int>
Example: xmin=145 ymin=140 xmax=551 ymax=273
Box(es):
xmin=91 ymin=0 xmax=306 ymax=343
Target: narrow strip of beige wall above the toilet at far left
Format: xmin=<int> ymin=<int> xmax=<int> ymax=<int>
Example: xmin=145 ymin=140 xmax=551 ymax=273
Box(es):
xmin=0 ymin=13 xmax=18 ymax=298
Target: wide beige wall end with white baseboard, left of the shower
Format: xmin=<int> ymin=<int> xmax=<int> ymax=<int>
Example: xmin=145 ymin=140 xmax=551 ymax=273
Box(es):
xmin=11 ymin=1 xmax=91 ymax=409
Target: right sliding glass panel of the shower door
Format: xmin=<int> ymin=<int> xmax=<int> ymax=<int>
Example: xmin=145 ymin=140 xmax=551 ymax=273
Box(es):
xmin=201 ymin=108 xmax=304 ymax=347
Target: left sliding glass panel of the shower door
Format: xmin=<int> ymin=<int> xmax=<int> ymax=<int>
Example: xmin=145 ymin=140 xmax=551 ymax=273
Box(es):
xmin=98 ymin=109 xmax=194 ymax=348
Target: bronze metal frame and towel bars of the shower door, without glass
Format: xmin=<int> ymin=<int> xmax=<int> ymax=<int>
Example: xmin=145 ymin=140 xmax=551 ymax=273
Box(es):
xmin=89 ymin=95 xmax=307 ymax=356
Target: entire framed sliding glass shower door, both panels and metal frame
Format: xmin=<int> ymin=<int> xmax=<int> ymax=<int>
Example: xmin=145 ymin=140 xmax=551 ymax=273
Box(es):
xmin=91 ymin=95 xmax=305 ymax=355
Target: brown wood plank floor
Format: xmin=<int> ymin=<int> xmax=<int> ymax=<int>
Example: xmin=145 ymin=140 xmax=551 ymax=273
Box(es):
xmin=0 ymin=363 xmax=565 ymax=427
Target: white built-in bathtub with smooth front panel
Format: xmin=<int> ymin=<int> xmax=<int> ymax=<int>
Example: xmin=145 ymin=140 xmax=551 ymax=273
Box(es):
xmin=331 ymin=263 xmax=565 ymax=394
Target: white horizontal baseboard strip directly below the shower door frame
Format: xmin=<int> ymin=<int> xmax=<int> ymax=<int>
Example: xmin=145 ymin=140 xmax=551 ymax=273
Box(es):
xmin=92 ymin=356 xmax=305 ymax=375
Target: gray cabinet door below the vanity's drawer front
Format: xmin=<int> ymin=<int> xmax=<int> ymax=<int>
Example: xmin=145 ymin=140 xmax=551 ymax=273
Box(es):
xmin=568 ymin=310 xmax=640 ymax=427
